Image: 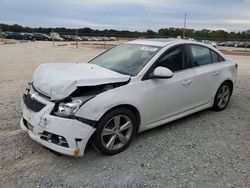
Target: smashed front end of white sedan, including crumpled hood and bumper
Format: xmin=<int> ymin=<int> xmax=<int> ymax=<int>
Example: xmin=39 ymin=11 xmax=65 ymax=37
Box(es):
xmin=20 ymin=63 xmax=130 ymax=157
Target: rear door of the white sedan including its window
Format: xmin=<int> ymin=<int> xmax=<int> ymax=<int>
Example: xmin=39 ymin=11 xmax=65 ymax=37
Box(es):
xmin=189 ymin=44 xmax=221 ymax=108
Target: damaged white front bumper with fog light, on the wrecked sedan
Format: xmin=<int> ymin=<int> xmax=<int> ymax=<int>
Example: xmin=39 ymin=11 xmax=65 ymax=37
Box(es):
xmin=20 ymin=88 xmax=95 ymax=157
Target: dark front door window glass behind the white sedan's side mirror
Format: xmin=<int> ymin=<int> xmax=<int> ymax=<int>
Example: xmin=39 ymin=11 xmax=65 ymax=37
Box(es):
xmin=157 ymin=46 xmax=187 ymax=72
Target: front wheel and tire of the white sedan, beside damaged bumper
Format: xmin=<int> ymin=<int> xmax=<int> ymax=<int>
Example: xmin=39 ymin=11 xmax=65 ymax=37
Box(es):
xmin=91 ymin=108 xmax=138 ymax=155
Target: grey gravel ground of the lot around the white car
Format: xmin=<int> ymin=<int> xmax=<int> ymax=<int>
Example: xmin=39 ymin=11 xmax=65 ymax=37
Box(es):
xmin=0 ymin=42 xmax=250 ymax=188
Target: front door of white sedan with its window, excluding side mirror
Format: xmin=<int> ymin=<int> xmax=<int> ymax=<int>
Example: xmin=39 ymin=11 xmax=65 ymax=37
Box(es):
xmin=145 ymin=45 xmax=194 ymax=126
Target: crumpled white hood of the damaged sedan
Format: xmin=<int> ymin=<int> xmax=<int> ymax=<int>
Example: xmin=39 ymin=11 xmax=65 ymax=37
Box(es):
xmin=33 ymin=63 xmax=130 ymax=100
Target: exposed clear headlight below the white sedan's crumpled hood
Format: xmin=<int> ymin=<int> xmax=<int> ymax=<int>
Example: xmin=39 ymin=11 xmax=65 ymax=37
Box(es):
xmin=54 ymin=99 xmax=83 ymax=117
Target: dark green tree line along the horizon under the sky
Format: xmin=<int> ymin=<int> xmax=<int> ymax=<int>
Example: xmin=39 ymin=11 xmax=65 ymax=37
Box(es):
xmin=0 ymin=24 xmax=250 ymax=40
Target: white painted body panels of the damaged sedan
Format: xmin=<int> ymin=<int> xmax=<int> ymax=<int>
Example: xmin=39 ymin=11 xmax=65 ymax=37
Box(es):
xmin=21 ymin=40 xmax=237 ymax=156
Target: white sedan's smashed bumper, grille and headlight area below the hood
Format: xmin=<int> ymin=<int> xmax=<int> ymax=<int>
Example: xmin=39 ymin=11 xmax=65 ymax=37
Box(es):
xmin=20 ymin=79 xmax=127 ymax=157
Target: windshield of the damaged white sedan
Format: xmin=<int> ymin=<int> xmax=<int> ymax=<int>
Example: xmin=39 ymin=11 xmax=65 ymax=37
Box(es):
xmin=89 ymin=44 xmax=160 ymax=76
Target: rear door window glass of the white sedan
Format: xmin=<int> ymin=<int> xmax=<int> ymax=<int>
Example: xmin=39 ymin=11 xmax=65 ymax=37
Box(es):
xmin=190 ymin=45 xmax=213 ymax=66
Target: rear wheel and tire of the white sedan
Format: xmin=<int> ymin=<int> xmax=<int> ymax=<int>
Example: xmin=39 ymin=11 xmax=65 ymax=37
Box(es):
xmin=213 ymin=82 xmax=233 ymax=111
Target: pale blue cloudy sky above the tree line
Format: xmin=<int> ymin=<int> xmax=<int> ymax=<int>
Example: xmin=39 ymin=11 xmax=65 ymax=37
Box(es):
xmin=0 ymin=0 xmax=250 ymax=31
